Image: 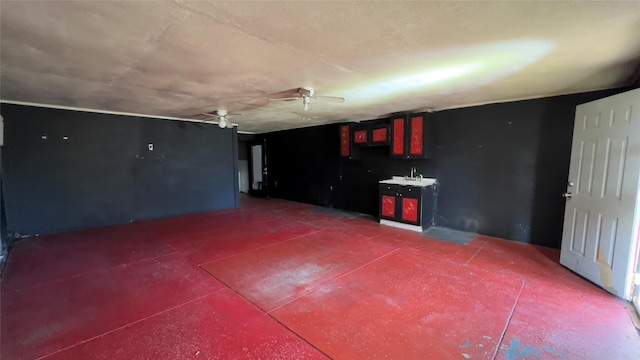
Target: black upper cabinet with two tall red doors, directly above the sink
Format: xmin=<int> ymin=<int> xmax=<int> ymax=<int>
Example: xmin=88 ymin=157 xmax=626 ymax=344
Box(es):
xmin=391 ymin=114 xmax=430 ymax=159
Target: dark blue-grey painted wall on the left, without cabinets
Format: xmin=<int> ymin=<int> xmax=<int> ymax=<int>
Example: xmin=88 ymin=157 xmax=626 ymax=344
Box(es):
xmin=1 ymin=104 xmax=238 ymax=235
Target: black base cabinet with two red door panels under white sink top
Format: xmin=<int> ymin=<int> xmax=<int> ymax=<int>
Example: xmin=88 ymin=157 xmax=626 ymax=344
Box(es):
xmin=379 ymin=184 xmax=433 ymax=229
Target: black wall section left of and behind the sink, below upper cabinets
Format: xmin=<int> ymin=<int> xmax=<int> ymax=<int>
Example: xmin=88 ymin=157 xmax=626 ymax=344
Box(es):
xmin=265 ymin=119 xmax=435 ymax=216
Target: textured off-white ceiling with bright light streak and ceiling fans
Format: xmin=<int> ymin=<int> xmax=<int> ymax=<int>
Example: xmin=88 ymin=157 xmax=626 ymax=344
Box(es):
xmin=0 ymin=1 xmax=640 ymax=132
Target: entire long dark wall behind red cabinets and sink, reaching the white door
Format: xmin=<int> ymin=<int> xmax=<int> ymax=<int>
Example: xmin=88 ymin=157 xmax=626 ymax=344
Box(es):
xmin=265 ymin=89 xmax=625 ymax=247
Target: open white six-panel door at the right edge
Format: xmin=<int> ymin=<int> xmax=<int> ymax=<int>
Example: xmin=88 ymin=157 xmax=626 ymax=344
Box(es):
xmin=560 ymin=89 xmax=640 ymax=299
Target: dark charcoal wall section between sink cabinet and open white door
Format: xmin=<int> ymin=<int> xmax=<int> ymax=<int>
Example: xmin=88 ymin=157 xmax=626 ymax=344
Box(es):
xmin=435 ymin=91 xmax=612 ymax=247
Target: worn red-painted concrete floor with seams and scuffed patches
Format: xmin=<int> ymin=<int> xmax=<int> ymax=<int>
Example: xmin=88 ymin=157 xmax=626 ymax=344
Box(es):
xmin=0 ymin=198 xmax=640 ymax=360
